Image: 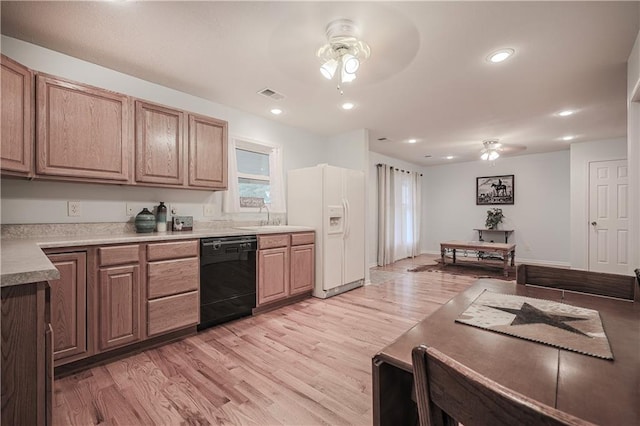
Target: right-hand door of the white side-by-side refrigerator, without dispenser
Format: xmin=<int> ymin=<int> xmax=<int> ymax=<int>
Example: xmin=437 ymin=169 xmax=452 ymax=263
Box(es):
xmin=344 ymin=170 xmax=365 ymax=284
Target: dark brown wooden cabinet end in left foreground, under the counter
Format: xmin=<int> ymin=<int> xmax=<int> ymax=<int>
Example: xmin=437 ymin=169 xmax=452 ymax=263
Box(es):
xmin=0 ymin=282 xmax=53 ymax=425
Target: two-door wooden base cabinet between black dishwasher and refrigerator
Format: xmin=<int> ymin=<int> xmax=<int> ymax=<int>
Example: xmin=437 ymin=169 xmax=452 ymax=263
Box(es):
xmin=257 ymin=232 xmax=315 ymax=308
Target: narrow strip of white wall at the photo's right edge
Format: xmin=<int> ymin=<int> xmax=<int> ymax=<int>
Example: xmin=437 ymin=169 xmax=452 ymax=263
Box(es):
xmin=627 ymin=32 xmax=640 ymax=273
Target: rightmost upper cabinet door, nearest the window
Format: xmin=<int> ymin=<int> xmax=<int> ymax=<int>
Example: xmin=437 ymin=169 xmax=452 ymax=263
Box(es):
xmin=189 ymin=114 xmax=227 ymax=189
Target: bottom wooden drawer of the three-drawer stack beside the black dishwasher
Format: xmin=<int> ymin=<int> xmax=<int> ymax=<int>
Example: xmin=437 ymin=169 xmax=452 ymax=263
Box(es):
xmin=147 ymin=291 xmax=200 ymax=336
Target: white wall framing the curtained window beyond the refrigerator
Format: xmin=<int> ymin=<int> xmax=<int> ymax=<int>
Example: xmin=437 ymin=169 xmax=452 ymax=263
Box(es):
xmin=367 ymin=152 xmax=426 ymax=267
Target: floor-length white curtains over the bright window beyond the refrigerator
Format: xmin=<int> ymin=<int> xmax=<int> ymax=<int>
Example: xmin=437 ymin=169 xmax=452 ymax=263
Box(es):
xmin=378 ymin=164 xmax=421 ymax=266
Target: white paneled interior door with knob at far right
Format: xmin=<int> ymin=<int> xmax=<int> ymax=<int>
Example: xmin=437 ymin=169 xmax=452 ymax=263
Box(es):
xmin=589 ymin=160 xmax=629 ymax=274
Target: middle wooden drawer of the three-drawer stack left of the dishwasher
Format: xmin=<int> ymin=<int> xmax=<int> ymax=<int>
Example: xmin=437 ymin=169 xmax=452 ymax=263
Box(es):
xmin=147 ymin=257 xmax=200 ymax=299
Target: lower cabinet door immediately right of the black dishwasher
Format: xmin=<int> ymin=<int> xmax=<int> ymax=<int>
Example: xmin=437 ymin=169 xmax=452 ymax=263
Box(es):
xmin=258 ymin=247 xmax=289 ymax=306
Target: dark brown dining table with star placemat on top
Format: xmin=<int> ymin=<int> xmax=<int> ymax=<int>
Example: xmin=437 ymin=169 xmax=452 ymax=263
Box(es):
xmin=372 ymin=279 xmax=640 ymax=425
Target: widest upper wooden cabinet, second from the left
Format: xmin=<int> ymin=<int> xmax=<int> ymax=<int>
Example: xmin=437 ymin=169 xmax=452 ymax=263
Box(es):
xmin=36 ymin=74 xmax=131 ymax=182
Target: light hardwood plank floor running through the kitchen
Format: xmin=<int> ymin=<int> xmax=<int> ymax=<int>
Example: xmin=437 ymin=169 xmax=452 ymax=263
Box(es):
xmin=53 ymin=256 xmax=474 ymax=425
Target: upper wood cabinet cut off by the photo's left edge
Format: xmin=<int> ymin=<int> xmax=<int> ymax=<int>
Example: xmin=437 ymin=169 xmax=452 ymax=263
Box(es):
xmin=0 ymin=55 xmax=34 ymax=176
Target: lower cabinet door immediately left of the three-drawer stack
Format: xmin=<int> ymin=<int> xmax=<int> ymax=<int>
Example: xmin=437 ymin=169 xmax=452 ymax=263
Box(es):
xmin=98 ymin=265 xmax=141 ymax=350
